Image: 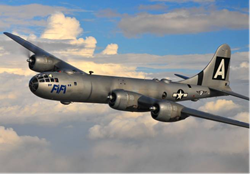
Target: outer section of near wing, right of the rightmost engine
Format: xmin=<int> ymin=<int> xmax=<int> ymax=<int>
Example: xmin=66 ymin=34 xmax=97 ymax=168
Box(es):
xmin=181 ymin=107 xmax=250 ymax=129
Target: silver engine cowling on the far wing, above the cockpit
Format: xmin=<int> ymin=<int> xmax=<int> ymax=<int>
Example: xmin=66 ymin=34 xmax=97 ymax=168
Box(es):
xmin=27 ymin=55 xmax=55 ymax=72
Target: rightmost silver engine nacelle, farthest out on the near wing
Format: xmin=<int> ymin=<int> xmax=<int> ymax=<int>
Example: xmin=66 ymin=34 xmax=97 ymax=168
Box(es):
xmin=151 ymin=101 xmax=188 ymax=122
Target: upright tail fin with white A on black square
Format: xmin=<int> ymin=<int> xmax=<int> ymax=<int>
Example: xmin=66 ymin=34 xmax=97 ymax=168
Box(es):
xmin=180 ymin=44 xmax=231 ymax=89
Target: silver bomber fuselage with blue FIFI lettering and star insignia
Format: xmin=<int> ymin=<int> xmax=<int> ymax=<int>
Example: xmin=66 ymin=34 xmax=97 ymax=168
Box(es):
xmin=30 ymin=72 xmax=214 ymax=103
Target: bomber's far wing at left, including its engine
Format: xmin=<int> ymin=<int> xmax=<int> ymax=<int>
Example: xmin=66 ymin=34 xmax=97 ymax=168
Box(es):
xmin=4 ymin=32 xmax=86 ymax=74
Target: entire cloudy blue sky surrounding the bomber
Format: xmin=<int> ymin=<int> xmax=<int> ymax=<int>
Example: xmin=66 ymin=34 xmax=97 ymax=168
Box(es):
xmin=0 ymin=0 xmax=250 ymax=173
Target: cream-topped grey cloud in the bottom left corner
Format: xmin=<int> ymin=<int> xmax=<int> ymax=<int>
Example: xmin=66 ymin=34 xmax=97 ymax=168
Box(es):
xmin=0 ymin=127 xmax=77 ymax=173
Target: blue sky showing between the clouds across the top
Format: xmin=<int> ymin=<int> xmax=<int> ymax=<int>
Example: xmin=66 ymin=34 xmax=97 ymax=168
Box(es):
xmin=2 ymin=0 xmax=249 ymax=55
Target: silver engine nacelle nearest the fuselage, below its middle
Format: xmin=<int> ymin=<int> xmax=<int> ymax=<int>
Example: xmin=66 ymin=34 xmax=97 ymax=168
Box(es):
xmin=108 ymin=90 xmax=144 ymax=112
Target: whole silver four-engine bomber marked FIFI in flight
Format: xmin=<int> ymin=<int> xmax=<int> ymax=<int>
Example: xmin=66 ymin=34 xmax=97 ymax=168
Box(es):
xmin=4 ymin=32 xmax=250 ymax=128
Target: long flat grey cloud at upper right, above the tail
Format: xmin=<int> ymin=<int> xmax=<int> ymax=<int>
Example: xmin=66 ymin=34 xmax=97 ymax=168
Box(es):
xmin=119 ymin=8 xmax=248 ymax=36
